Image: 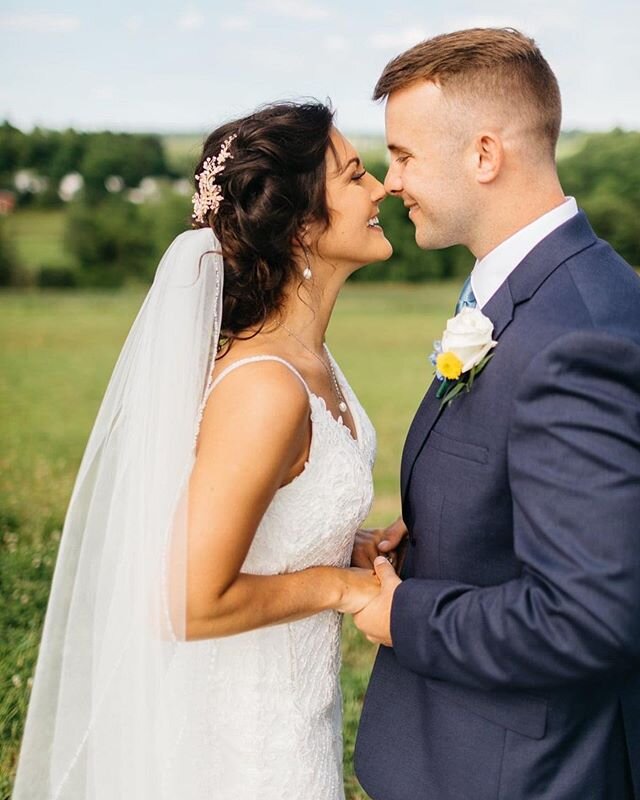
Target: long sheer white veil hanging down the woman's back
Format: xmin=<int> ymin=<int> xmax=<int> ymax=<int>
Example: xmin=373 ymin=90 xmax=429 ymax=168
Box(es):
xmin=13 ymin=228 xmax=228 ymax=800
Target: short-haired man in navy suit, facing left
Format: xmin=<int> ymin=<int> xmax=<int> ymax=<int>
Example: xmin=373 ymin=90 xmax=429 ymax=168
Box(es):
xmin=355 ymin=29 xmax=640 ymax=800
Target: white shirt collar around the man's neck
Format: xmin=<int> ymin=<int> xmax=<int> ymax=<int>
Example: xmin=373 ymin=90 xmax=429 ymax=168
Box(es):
xmin=471 ymin=197 xmax=578 ymax=308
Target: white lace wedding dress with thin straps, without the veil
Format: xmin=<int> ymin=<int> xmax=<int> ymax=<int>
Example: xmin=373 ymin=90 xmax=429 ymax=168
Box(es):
xmin=166 ymin=356 xmax=376 ymax=800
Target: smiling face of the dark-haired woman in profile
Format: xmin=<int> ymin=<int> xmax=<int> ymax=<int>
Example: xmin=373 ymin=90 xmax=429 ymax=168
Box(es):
xmin=313 ymin=129 xmax=393 ymax=273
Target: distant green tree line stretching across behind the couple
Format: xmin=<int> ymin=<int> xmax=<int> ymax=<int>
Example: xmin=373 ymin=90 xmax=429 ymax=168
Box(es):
xmin=0 ymin=123 xmax=640 ymax=287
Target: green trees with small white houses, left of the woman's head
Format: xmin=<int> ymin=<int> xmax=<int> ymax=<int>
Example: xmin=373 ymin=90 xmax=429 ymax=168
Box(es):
xmin=0 ymin=121 xmax=191 ymax=287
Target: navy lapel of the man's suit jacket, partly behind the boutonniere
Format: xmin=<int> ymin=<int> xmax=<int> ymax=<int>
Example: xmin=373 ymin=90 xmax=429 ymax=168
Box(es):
xmin=400 ymin=211 xmax=597 ymax=504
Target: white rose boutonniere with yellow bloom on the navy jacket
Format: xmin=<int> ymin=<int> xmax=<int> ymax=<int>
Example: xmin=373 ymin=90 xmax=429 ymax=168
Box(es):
xmin=430 ymin=307 xmax=498 ymax=406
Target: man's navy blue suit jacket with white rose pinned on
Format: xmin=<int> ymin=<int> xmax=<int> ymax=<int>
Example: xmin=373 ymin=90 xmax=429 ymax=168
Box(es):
xmin=355 ymin=213 xmax=640 ymax=800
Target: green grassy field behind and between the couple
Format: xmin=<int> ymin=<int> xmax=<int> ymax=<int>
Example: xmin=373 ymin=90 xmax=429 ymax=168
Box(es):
xmin=0 ymin=285 xmax=458 ymax=800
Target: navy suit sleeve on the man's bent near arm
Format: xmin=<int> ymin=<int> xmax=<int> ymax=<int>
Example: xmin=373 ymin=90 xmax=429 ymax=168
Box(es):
xmin=391 ymin=331 xmax=640 ymax=689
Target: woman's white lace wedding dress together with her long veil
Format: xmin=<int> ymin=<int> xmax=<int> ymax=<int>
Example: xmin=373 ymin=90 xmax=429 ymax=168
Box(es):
xmin=12 ymin=228 xmax=375 ymax=800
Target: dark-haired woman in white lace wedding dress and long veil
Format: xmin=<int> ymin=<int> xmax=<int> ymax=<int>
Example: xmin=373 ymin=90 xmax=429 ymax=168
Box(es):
xmin=13 ymin=103 xmax=391 ymax=800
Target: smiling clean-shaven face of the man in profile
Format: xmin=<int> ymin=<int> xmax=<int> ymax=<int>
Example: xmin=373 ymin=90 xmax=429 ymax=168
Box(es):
xmin=384 ymin=81 xmax=474 ymax=250
